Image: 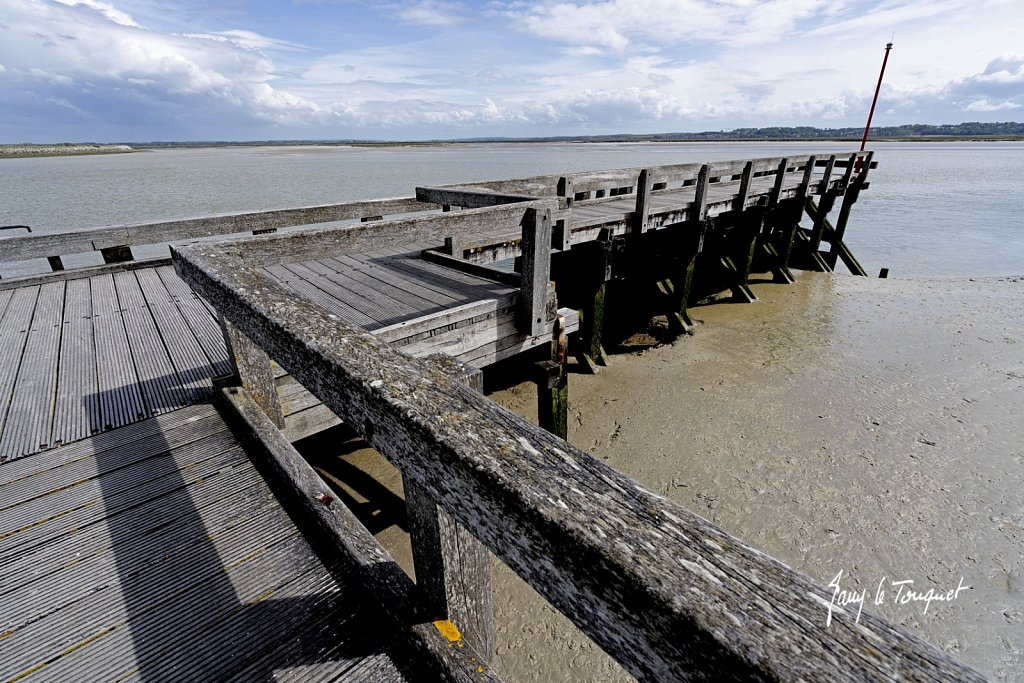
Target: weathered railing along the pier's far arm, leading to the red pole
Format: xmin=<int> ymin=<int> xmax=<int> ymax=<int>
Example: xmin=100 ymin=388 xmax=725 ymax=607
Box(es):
xmin=416 ymin=152 xmax=877 ymax=274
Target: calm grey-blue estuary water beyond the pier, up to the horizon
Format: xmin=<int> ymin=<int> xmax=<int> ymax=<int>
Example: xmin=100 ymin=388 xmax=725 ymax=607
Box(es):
xmin=0 ymin=142 xmax=1024 ymax=278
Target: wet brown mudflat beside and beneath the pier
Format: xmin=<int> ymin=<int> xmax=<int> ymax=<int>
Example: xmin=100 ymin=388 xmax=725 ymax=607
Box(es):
xmin=311 ymin=273 xmax=1024 ymax=681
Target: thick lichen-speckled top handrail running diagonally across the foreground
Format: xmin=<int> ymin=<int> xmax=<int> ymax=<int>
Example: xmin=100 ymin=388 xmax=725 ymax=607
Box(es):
xmin=173 ymin=194 xmax=985 ymax=681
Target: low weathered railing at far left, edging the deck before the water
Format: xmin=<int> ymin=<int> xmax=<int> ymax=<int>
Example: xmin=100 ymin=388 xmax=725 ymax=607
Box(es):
xmin=0 ymin=198 xmax=439 ymax=282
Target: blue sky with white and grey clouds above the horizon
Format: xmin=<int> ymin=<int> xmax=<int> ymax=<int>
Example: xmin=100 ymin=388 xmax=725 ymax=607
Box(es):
xmin=0 ymin=0 xmax=1024 ymax=143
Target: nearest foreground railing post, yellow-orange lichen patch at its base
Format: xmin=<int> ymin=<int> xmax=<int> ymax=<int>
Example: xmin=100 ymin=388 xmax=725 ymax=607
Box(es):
xmin=402 ymin=355 xmax=495 ymax=664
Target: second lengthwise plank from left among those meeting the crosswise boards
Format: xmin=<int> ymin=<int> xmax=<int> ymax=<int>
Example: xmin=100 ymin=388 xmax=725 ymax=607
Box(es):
xmin=51 ymin=278 xmax=102 ymax=445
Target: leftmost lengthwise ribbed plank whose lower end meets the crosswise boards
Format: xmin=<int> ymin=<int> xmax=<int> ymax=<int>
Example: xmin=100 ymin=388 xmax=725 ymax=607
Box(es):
xmin=0 ymin=283 xmax=65 ymax=461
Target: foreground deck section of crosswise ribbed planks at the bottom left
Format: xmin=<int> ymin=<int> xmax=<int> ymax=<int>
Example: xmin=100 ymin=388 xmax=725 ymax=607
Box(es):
xmin=0 ymin=404 xmax=410 ymax=682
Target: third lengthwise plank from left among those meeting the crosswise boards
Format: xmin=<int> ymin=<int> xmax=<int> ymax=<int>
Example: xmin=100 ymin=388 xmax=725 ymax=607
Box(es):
xmin=90 ymin=274 xmax=146 ymax=429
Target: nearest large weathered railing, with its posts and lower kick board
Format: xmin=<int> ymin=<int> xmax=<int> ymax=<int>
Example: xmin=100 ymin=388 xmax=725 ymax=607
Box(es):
xmin=173 ymin=198 xmax=984 ymax=681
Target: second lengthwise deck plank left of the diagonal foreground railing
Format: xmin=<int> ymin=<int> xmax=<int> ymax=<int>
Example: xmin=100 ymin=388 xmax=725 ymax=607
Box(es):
xmin=135 ymin=270 xmax=213 ymax=404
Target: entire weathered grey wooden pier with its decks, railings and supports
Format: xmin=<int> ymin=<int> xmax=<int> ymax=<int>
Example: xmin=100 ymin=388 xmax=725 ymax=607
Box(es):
xmin=0 ymin=153 xmax=983 ymax=681
